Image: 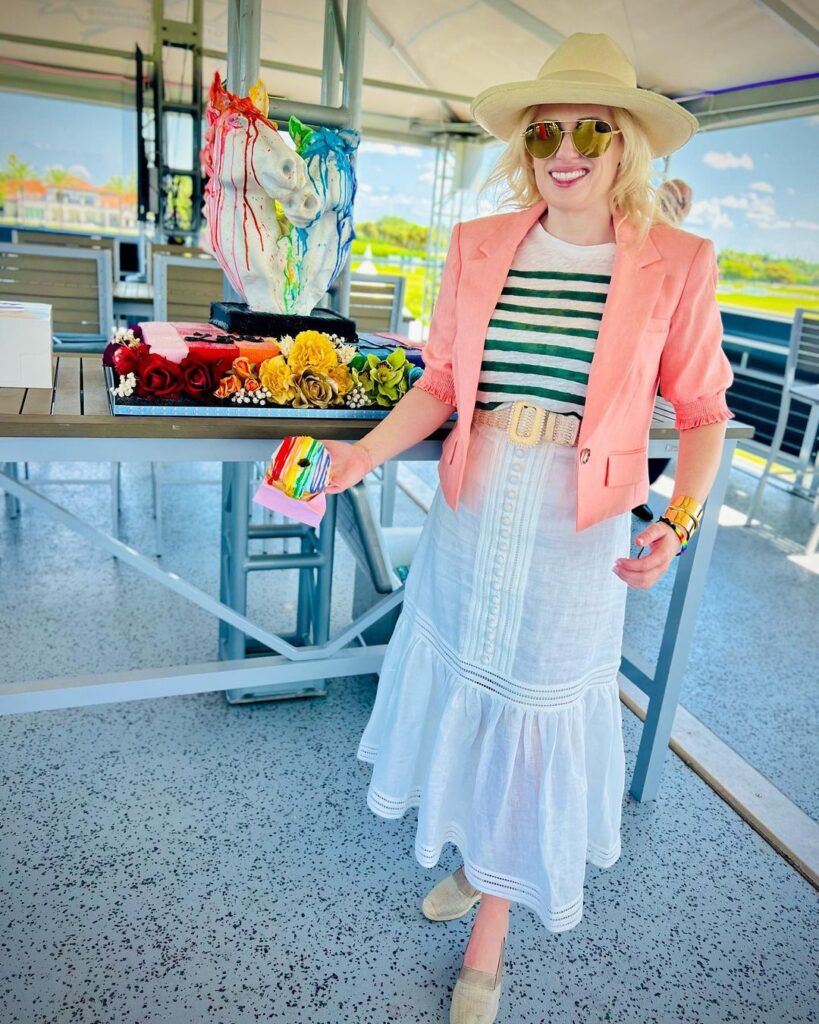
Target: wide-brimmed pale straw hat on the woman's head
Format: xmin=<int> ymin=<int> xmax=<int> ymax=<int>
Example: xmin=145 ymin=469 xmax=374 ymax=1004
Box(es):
xmin=470 ymin=32 xmax=699 ymax=157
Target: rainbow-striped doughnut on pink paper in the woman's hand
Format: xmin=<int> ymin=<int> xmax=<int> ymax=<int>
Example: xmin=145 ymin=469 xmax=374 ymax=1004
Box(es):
xmin=253 ymin=434 xmax=331 ymax=526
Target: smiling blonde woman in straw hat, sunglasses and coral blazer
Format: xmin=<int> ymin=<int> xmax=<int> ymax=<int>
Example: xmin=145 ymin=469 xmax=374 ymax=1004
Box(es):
xmin=328 ymin=34 xmax=733 ymax=1024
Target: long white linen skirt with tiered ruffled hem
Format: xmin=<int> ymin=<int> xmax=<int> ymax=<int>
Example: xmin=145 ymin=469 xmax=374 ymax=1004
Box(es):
xmin=357 ymin=411 xmax=631 ymax=932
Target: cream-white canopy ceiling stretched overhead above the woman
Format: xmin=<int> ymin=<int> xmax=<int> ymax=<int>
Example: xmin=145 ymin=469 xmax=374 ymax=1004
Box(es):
xmin=0 ymin=0 xmax=819 ymax=137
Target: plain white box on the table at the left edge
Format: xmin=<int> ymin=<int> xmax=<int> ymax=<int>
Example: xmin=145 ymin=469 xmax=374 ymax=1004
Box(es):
xmin=0 ymin=302 xmax=52 ymax=387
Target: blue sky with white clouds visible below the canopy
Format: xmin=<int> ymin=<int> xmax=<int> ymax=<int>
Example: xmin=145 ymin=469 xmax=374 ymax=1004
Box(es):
xmin=0 ymin=93 xmax=819 ymax=262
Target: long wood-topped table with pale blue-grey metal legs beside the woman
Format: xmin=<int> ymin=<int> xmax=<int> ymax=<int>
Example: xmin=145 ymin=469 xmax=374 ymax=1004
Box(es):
xmin=0 ymin=354 xmax=753 ymax=801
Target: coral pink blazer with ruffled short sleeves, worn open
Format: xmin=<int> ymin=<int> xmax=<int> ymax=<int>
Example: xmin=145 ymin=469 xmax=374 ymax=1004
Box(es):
xmin=415 ymin=201 xmax=734 ymax=530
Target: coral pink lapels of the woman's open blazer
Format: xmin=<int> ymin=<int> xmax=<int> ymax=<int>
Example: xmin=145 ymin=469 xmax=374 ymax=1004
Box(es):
xmin=456 ymin=200 xmax=664 ymax=445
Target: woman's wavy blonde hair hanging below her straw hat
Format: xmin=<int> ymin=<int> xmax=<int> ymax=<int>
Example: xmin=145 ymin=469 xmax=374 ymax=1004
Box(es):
xmin=478 ymin=103 xmax=676 ymax=245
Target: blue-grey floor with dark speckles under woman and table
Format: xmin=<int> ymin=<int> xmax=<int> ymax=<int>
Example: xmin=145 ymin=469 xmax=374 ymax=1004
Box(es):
xmin=0 ymin=464 xmax=819 ymax=1024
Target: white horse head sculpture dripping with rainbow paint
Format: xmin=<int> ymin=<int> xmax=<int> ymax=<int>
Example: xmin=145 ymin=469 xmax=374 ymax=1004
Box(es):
xmin=201 ymin=72 xmax=359 ymax=315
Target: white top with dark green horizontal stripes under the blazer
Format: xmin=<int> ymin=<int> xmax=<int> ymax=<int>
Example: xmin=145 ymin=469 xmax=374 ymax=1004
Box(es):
xmin=475 ymin=220 xmax=616 ymax=416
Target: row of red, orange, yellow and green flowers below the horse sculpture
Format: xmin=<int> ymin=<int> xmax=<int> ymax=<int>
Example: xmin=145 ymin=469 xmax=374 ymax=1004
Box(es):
xmin=102 ymin=327 xmax=421 ymax=409
